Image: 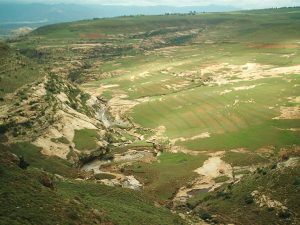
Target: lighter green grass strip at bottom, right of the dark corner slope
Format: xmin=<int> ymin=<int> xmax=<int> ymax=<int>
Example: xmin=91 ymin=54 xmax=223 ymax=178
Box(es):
xmin=57 ymin=182 xmax=184 ymax=225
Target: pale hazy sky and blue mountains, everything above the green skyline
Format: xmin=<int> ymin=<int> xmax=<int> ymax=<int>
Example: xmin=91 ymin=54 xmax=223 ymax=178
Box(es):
xmin=0 ymin=0 xmax=300 ymax=36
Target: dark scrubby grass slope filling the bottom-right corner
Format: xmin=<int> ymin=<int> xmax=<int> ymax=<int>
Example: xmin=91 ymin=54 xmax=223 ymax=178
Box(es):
xmin=192 ymin=164 xmax=300 ymax=224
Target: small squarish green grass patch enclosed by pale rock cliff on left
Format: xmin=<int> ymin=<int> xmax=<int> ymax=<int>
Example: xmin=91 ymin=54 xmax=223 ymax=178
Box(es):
xmin=73 ymin=129 xmax=99 ymax=150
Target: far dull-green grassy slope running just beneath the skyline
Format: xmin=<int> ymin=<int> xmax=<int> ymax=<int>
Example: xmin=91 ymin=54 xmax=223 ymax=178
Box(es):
xmin=33 ymin=9 xmax=300 ymax=41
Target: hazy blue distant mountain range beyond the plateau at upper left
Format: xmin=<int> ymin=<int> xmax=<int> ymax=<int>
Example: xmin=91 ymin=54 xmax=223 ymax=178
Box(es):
xmin=0 ymin=3 xmax=237 ymax=37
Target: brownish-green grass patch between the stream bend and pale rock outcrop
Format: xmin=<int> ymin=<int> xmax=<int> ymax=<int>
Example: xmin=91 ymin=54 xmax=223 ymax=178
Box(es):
xmin=125 ymin=152 xmax=208 ymax=200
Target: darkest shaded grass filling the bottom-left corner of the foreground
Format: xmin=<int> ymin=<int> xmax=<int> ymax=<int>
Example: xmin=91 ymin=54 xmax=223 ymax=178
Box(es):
xmin=0 ymin=146 xmax=109 ymax=225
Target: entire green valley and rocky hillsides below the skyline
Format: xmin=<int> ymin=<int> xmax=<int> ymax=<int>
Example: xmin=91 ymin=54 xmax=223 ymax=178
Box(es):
xmin=0 ymin=8 xmax=300 ymax=224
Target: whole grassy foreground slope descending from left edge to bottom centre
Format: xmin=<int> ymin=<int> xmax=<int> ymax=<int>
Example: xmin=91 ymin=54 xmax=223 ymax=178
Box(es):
xmin=0 ymin=145 xmax=184 ymax=224
